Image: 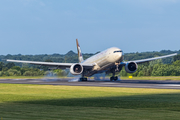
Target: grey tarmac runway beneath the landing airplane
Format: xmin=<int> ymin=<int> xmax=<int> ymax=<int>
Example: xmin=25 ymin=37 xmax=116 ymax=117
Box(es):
xmin=0 ymin=79 xmax=180 ymax=89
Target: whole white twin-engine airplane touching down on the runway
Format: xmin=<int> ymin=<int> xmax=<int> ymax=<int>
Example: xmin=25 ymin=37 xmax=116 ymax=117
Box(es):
xmin=6 ymin=39 xmax=177 ymax=81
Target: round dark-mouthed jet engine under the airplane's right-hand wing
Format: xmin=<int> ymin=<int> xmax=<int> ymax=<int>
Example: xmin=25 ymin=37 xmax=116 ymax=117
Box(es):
xmin=125 ymin=62 xmax=138 ymax=73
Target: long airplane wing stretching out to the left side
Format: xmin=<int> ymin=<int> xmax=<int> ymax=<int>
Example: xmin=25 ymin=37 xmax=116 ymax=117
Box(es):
xmin=6 ymin=59 xmax=94 ymax=69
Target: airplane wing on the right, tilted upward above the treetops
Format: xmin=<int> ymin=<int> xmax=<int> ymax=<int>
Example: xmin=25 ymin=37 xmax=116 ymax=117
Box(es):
xmin=121 ymin=53 xmax=177 ymax=65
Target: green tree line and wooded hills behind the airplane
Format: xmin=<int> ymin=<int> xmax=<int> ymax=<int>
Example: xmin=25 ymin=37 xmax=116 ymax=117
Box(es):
xmin=0 ymin=50 xmax=180 ymax=76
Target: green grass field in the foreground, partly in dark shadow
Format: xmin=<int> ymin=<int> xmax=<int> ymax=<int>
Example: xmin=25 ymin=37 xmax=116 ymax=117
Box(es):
xmin=0 ymin=84 xmax=180 ymax=120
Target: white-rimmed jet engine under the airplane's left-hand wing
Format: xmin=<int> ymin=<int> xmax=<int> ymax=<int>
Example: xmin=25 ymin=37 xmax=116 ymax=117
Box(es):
xmin=70 ymin=64 xmax=83 ymax=75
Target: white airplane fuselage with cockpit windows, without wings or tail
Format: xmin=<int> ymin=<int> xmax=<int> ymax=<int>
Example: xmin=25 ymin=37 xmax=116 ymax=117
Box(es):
xmin=83 ymin=47 xmax=123 ymax=76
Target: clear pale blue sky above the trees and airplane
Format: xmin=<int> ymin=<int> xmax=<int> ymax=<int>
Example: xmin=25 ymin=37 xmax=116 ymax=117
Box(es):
xmin=0 ymin=0 xmax=180 ymax=55
